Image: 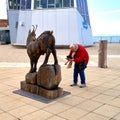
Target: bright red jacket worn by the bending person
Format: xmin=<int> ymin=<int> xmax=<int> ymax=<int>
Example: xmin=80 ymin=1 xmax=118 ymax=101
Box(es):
xmin=69 ymin=44 xmax=89 ymax=64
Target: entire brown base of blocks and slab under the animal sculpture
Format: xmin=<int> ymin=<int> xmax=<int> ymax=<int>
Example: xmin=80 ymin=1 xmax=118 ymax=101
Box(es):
xmin=21 ymin=65 xmax=63 ymax=99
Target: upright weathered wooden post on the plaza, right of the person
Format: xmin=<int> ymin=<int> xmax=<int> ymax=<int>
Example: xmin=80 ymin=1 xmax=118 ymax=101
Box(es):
xmin=98 ymin=40 xmax=107 ymax=68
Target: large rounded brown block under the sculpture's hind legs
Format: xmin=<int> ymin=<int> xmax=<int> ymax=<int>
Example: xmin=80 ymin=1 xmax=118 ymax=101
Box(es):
xmin=37 ymin=65 xmax=61 ymax=90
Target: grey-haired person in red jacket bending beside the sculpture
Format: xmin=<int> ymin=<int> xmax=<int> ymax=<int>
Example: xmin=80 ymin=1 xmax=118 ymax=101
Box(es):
xmin=66 ymin=44 xmax=89 ymax=88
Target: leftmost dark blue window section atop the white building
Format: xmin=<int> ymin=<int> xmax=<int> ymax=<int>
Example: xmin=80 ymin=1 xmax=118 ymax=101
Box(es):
xmin=8 ymin=0 xmax=31 ymax=10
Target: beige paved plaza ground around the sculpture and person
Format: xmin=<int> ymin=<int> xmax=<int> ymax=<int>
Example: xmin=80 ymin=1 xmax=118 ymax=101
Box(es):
xmin=0 ymin=43 xmax=120 ymax=120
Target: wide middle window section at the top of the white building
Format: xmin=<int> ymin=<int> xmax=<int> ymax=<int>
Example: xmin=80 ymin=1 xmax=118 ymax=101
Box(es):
xmin=34 ymin=0 xmax=74 ymax=9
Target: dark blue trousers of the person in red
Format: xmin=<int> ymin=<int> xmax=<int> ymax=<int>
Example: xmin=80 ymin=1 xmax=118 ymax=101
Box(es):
xmin=73 ymin=66 xmax=85 ymax=84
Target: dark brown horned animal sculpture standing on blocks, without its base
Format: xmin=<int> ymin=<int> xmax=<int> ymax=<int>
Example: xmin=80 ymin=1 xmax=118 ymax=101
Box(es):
xmin=26 ymin=26 xmax=58 ymax=73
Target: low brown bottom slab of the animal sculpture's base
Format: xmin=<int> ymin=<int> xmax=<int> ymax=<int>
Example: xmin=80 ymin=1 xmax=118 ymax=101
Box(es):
xmin=21 ymin=81 xmax=63 ymax=99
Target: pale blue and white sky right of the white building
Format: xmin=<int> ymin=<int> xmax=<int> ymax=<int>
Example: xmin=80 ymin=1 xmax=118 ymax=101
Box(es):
xmin=87 ymin=0 xmax=120 ymax=35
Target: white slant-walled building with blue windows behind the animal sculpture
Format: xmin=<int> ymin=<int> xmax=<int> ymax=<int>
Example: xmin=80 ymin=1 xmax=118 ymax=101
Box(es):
xmin=8 ymin=0 xmax=93 ymax=46
